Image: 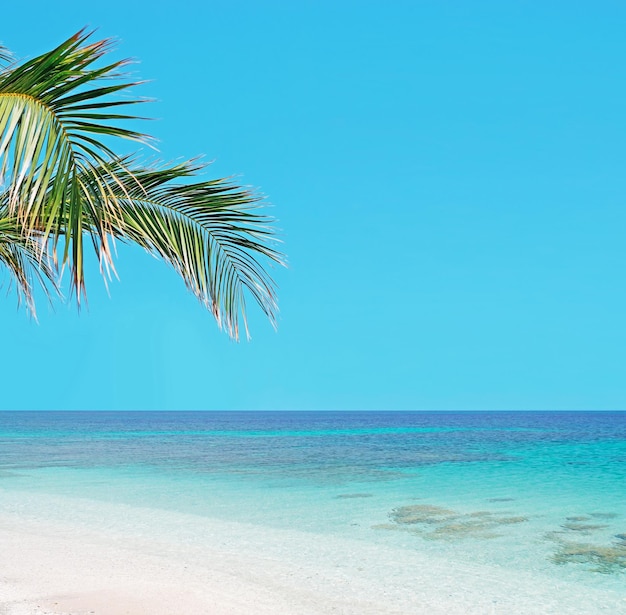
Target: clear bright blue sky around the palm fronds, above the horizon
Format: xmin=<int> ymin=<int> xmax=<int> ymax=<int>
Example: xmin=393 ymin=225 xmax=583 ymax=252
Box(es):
xmin=0 ymin=0 xmax=626 ymax=410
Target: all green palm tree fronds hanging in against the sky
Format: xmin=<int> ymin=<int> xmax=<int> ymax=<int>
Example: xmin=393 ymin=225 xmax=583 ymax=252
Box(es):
xmin=0 ymin=30 xmax=283 ymax=339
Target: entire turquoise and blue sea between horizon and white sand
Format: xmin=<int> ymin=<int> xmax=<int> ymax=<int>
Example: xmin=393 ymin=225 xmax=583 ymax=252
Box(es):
xmin=0 ymin=412 xmax=626 ymax=597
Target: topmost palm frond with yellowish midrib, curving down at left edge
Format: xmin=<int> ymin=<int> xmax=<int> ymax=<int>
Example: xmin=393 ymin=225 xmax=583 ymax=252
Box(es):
xmin=0 ymin=31 xmax=149 ymax=301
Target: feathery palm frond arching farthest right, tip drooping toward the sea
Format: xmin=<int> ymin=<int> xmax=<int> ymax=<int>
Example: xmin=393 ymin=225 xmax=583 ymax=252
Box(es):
xmin=88 ymin=162 xmax=283 ymax=339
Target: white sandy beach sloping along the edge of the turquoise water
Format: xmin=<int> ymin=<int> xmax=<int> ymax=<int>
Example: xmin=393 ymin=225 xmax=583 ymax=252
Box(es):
xmin=0 ymin=496 xmax=626 ymax=615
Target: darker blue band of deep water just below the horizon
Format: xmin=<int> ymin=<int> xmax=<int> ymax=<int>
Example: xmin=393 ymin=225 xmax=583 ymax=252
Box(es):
xmin=0 ymin=412 xmax=626 ymax=476
